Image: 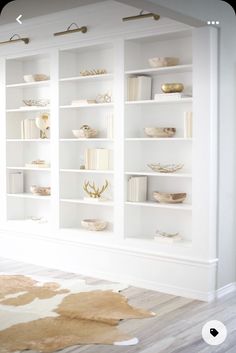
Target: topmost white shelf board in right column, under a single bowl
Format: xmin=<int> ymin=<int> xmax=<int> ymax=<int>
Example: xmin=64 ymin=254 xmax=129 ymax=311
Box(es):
xmin=125 ymin=64 xmax=193 ymax=75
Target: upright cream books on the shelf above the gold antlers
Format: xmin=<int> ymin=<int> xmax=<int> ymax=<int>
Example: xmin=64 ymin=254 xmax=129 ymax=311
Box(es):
xmin=85 ymin=148 xmax=111 ymax=170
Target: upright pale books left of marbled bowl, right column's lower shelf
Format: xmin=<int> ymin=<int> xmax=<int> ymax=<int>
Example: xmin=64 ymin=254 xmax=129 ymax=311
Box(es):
xmin=128 ymin=176 xmax=147 ymax=202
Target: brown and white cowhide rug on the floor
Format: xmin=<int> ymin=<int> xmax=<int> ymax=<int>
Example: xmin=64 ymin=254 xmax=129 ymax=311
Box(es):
xmin=0 ymin=273 xmax=155 ymax=353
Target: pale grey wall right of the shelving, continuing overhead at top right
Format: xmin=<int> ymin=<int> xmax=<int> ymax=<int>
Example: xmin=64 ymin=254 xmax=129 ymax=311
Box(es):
xmin=144 ymin=0 xmax=236 ymax=288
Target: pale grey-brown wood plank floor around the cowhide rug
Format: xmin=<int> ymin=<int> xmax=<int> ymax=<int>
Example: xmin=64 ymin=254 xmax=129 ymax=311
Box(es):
xmin=0 ymin=259 xmax=236 ymax=353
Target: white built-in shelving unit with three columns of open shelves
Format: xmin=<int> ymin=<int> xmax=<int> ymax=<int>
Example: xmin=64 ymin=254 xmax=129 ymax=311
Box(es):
xmin=0 ymin=9 xmax=216 ymax=297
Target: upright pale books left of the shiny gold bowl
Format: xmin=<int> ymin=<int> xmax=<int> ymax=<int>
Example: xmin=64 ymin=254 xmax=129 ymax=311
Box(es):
xmin=127 ymin=76 xmax=152 ymax=101
